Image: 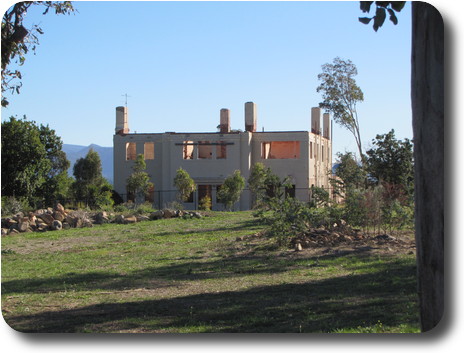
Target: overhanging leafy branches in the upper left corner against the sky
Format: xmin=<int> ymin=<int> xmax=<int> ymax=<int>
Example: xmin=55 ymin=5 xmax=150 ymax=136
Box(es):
xmin=2 ymin=1 xmax=75 ymax=107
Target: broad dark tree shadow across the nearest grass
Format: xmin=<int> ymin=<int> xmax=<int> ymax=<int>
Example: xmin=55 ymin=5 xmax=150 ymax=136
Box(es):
xmin=5 ymin=263 xmax=419 ymax=333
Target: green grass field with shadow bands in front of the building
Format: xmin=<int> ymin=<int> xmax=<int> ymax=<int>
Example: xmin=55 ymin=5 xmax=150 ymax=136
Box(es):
xmin=2 ymin=212 xmax=419 ymax=333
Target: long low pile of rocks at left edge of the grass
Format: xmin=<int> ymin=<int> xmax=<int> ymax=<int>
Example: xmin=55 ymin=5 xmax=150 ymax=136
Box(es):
xmin=1 ymin=204 xmax=202 ymax=236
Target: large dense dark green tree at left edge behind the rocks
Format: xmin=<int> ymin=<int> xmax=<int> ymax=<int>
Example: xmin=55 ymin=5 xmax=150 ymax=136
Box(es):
xmin=1 ymin=117 xmax=70 ymax=204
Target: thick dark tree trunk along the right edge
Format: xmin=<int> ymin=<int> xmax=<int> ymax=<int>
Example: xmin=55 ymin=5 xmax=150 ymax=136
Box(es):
xmin=411 ymin=1 xmax=444 ymax=332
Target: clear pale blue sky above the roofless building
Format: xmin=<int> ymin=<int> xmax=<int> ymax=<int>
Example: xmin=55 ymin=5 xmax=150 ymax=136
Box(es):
xmin=2 ymin=1 xmax=412 ymax=158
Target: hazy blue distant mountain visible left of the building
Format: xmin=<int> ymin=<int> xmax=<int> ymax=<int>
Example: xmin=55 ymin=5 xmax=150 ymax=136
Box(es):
xmin=62 ymin=144 xmax=113 ymax=184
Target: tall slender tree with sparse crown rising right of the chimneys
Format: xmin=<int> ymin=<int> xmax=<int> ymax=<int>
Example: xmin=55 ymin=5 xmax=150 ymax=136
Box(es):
xmin=317 ymin=57 xmax=364 ymax=163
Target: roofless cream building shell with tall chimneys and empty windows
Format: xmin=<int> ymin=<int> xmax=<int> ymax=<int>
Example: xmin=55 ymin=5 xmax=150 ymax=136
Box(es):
xmin=113 ymin=102 xmax=332 ymax=210
